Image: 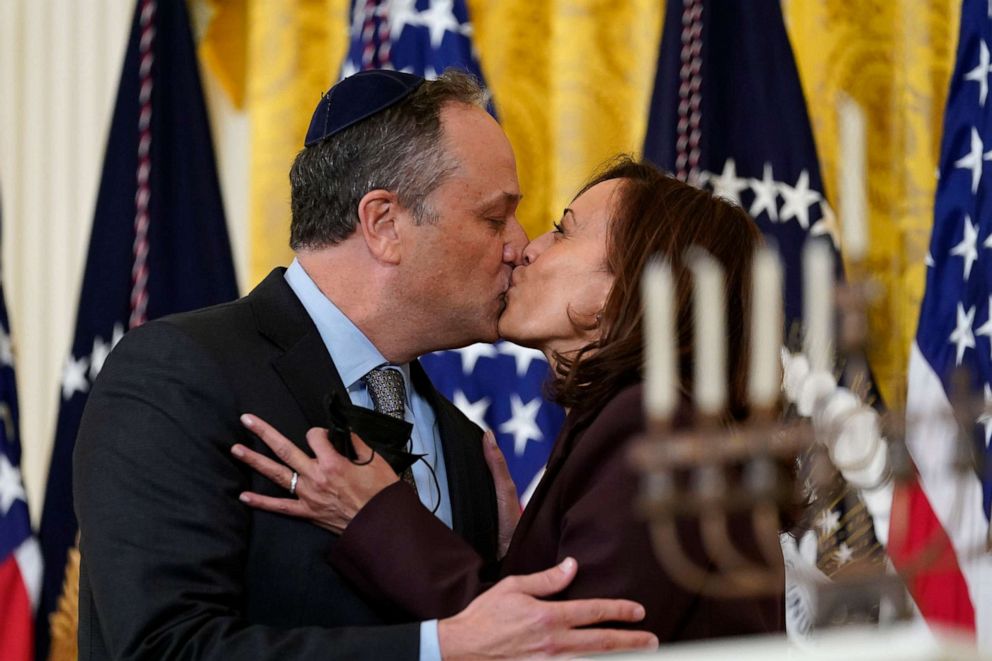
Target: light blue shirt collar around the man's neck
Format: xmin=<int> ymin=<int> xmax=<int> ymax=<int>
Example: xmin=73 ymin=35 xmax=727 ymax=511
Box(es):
xmin=285 ymin=259 xmax=410 ymax=392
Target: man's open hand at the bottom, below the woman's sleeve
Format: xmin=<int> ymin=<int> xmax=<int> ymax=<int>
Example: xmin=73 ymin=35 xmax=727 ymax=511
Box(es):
xmin=438 ymin=558 xmax=658 ymax=661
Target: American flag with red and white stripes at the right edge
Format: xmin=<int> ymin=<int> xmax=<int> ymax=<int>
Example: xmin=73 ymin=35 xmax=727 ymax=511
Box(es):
xmin=893 ymin=0 xmax=992 ymax=647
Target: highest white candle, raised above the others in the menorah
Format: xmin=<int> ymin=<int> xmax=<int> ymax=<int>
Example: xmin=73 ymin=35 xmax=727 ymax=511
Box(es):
xmin=837 ymin=96 xmax=868 ymax=262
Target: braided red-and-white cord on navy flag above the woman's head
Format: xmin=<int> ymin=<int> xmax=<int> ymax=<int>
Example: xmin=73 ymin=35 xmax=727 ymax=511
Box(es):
xmin=675 ymin=0 xmax=703 ymax=183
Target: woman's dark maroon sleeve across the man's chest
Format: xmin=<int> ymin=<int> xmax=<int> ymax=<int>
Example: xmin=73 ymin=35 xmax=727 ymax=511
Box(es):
xmin=330 ymin=481 xmax=498 ymax=620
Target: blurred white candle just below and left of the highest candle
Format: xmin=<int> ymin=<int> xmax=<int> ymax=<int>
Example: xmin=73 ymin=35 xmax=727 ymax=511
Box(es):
xmin=803 ymin=239 xmax=834 ymax=372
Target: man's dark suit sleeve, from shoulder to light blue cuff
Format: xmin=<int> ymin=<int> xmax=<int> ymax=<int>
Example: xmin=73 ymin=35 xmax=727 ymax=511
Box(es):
xmin=73 ymin=322 xmax=419 ymax=659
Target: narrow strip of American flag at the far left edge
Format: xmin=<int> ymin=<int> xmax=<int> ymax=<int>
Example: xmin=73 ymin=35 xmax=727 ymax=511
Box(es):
xmin=0 ymin=193 xmax=41 ymax=661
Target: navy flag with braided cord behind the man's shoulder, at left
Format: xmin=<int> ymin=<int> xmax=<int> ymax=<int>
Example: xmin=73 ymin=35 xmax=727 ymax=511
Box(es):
xmin=36 ymin=0 xmax=238 ymax=658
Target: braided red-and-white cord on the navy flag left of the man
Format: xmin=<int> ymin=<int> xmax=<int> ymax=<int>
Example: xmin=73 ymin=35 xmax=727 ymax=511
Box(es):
xmin=128 ymin=0 xmax=156 ymax=328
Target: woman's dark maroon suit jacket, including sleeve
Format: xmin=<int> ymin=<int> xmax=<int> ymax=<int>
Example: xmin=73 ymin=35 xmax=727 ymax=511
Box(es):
xmin=331 ymin=385 xmax=785 ymax=643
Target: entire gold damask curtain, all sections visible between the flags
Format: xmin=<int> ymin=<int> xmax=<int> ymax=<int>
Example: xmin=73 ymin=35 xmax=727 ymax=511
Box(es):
xmin=198 ymin=0 xmax=960 ymax=404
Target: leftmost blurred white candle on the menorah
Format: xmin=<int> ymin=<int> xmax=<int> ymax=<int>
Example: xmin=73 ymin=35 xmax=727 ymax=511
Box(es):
xmin=641 ymin=258 xmax=678 ymax=421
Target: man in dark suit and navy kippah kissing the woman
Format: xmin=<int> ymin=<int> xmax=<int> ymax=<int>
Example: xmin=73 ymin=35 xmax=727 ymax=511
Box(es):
xmin=74 ymin=72 xmax=656 ymax=660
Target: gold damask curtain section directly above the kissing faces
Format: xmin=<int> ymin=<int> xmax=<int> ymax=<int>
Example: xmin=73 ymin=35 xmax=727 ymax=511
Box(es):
xmin=468 ymin=0 xmax=664 ymax=242
